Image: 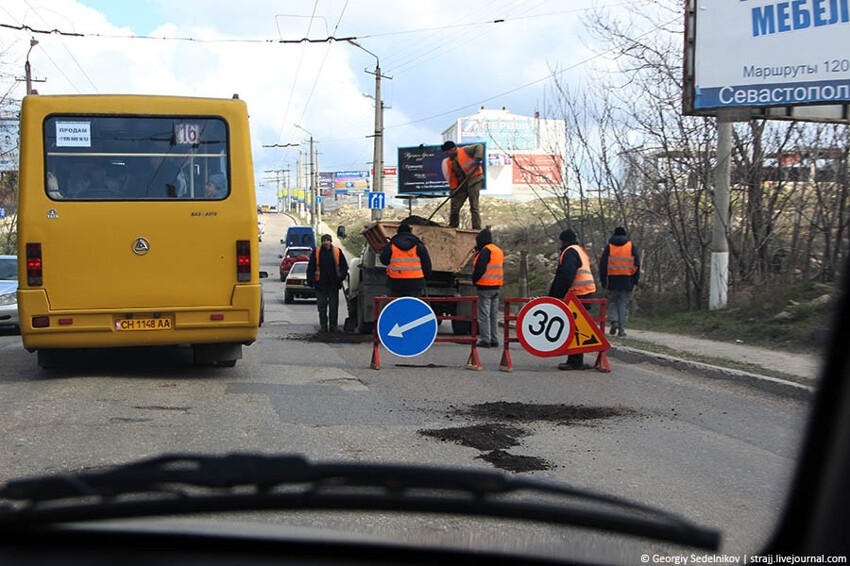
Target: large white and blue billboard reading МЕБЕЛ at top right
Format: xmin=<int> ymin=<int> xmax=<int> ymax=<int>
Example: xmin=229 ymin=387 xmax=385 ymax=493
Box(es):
xmin=685 ymin=0 xmax=850 ymax=120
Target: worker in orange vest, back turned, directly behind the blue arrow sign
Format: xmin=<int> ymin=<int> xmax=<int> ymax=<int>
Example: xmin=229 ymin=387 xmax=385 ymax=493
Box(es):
xmin=380 ymin=223 xmax=431 ymax=297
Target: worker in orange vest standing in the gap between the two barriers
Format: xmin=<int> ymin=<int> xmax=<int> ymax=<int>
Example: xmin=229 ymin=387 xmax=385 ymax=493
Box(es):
xmin=472 ymin=228 xmax=505 ymax=348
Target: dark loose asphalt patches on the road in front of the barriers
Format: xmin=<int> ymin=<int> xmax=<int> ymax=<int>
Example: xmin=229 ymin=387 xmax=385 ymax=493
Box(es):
xmin=419 ymin=401 xmax=637 ymax=473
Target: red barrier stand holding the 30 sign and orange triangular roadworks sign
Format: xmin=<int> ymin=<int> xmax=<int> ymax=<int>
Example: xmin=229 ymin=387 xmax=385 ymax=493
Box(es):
xmin=499 ymin=293 xmax=611 ymax=373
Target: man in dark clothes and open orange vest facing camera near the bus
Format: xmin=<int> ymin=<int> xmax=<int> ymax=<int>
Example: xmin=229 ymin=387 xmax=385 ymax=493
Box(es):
xmin=307 ymin=234 xmax=348 ymax=332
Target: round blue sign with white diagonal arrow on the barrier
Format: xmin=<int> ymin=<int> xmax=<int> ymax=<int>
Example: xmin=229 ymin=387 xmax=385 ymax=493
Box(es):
xmin=378 ymin=297 xmax=437 ymax=358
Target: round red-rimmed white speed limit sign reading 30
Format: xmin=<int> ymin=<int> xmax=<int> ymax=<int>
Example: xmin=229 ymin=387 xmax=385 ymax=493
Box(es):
xmin=516 ymin=297 xmax=575 ymax=358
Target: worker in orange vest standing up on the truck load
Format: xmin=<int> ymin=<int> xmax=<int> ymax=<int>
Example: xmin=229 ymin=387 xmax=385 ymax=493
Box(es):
xmin=440 ymin=141 xmax=484 ymax=230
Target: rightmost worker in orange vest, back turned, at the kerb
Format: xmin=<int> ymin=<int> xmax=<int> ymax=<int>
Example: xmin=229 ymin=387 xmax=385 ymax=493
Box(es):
xmin=599 ymin=227 xmax=640 ymax=336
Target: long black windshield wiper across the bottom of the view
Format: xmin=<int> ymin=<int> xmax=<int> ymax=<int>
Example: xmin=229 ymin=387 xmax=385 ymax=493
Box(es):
xmin=0 ymin=454 xmax=720 ymax=550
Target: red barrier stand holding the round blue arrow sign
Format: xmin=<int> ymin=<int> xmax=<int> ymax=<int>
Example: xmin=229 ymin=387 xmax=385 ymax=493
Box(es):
xmin=372 ymin=297 xmax=481 ymax=371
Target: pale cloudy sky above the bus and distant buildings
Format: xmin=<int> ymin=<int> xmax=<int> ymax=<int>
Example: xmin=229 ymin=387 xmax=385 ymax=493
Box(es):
xmin=0 ymin=0 xmax=646 ymax=203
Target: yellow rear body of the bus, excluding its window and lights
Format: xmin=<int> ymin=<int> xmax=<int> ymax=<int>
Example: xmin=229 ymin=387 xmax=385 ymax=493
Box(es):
xmin=18 ymin=95 xmax=262 ymax=349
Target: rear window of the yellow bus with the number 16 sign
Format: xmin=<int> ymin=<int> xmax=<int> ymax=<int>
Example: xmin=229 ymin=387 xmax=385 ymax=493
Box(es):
xmin=44 ymin=115 xmax=230 ymax=200
